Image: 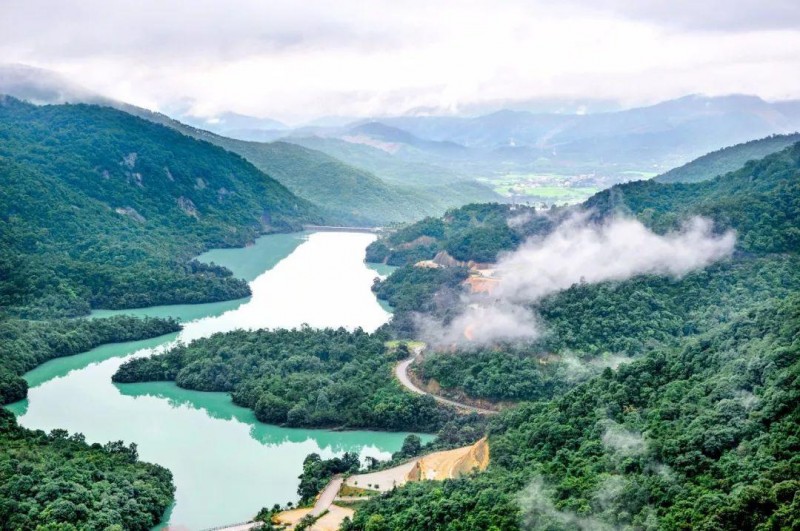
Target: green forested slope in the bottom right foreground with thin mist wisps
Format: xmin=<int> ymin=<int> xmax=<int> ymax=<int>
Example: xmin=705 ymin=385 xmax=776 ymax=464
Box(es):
xmin=346 ymin=296 xmax=800 ymax=530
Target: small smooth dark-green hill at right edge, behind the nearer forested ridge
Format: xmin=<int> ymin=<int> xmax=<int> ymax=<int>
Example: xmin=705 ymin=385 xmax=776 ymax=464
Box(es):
xmin=654 ymin=133 xmax=800 ymax=183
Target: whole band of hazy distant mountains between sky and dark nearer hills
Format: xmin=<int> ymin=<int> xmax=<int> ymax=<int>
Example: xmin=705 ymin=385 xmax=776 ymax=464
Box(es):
xmin=0 ymin=65 xmax=800 ymax=212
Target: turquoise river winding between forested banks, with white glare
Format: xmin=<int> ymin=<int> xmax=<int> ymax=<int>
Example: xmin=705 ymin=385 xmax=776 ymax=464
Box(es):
xmin=9 ymin=232 xmax=424 ymax=529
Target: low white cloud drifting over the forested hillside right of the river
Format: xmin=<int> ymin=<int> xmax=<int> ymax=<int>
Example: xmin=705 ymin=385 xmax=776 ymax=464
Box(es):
xmin=419 ymin=213 xmax=736 ymax=348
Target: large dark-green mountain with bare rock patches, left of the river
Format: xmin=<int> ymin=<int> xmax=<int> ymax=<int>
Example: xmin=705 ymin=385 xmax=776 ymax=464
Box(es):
xmin=0 ymin=97 xmax=322 ymax=316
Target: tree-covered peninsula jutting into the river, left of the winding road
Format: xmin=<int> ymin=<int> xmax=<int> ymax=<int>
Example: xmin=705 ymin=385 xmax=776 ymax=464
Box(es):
xmin=113 ymin=327 xmax=451 ymax=431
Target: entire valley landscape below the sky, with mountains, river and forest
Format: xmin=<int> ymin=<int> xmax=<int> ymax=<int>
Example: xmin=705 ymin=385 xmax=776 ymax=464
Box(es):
xmin=0 ymin=57 xmax=800 ymax=531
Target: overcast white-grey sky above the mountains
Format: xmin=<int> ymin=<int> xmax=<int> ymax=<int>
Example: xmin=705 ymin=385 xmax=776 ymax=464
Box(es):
xmin=0 ymin=0 xmax=800 ymax=123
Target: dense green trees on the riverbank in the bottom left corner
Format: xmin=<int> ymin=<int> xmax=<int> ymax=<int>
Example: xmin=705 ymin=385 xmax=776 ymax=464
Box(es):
xmin=0 ymin=408 xmax=175 ymax=531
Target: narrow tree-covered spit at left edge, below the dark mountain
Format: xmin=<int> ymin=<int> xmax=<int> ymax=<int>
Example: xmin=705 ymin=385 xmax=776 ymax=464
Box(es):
xmin=0 ymin=316 xmax=181 ymax=404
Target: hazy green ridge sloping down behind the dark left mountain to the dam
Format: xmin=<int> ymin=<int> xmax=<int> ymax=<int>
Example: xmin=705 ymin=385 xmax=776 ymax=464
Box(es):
xmin=0 ymin=65 xmax=500 ymax=225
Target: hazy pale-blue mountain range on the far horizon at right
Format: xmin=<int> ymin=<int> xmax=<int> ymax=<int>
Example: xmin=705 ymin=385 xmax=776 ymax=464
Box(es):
xmin=370 ymin=95 xmax=800 ymax=168
